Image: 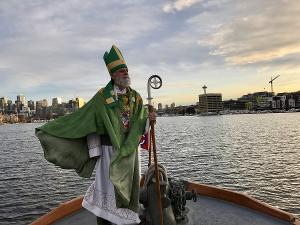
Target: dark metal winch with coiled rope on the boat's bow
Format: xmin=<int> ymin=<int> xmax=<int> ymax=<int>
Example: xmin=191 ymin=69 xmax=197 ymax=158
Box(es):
xmin=140 ymin=164 xmax=197 ymax=225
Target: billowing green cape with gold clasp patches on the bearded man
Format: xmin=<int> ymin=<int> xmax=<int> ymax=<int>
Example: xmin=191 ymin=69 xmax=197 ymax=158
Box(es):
xmin=36 ymin=82 xmax=147 ymax=212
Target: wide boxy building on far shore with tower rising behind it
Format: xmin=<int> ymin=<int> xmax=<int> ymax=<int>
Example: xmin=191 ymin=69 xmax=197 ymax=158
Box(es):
xmin=199 ymin=93 xmax=223 ymax=113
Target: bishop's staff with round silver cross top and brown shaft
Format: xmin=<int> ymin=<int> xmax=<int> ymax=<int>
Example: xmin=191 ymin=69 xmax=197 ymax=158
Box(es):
xmin=147 ymin=75 xmax=163 ymax=225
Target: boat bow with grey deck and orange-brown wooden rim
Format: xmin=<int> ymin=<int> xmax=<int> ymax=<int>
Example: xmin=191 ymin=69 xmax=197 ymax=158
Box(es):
xmin=31 ymin=182 xmax=300 ymax=225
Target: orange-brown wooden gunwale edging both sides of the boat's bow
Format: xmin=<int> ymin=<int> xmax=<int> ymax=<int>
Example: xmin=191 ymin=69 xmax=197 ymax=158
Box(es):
xmin=30 ymin=182 xmax=300 ymax=225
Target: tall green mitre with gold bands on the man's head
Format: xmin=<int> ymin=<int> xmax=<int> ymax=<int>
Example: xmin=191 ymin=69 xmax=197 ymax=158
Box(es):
xmin=103 ymin=45 xmax=127 ymax=74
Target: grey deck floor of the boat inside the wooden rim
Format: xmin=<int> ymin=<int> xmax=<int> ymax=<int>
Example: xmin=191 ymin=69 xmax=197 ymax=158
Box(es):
xmin=54 ymin=195 xmax=292 ymax=225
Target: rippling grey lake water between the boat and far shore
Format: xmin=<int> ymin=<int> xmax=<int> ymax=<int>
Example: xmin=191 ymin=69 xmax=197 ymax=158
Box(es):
xmin=0 ymin=113 xmax=300 ymax=225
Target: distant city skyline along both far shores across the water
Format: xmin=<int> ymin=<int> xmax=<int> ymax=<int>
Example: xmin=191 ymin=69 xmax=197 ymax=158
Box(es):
xmin=0 ymin=89 xmax=300 ymax=124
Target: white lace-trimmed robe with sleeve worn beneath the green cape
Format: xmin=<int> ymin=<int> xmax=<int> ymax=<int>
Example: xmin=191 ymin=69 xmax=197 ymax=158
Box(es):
xmin=82 ymin=134 xmax=140 ymax=225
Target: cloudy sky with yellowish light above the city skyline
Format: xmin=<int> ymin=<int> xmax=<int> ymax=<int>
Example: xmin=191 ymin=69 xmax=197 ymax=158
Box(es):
xmin=0 ymin=0 xmax=300 ymax=105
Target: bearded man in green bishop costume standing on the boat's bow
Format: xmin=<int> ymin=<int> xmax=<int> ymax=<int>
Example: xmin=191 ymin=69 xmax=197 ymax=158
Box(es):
xmin=36 ymin=45 xmax=155 ymax=225
